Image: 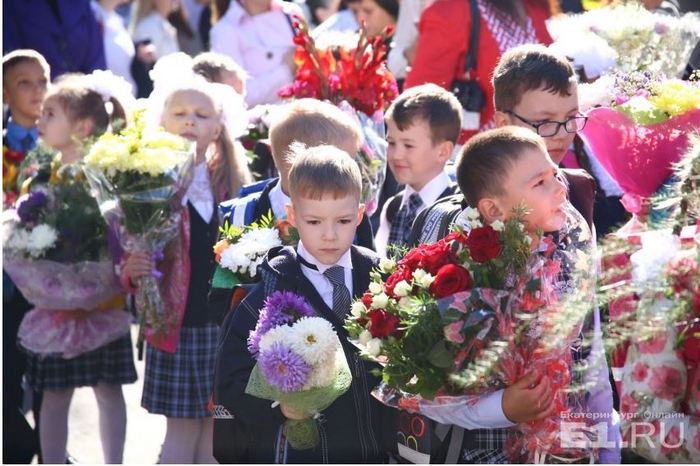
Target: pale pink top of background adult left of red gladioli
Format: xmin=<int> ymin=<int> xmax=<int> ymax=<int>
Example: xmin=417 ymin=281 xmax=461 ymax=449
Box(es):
xmin=210 ymin=0 xmax=302 ymax=107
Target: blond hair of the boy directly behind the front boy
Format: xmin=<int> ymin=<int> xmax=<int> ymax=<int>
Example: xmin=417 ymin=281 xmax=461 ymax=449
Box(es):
xmin=270 ymin=99 xmax=362 ymax=166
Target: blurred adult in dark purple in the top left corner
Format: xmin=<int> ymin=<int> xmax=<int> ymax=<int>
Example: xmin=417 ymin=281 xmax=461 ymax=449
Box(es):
xmin=2 ymin=0 xmax=107 ymax=79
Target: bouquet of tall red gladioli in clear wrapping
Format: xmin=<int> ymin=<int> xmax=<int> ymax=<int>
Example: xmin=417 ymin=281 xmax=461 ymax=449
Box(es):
xmin=279 ymin=19 xmax=398 ymax=215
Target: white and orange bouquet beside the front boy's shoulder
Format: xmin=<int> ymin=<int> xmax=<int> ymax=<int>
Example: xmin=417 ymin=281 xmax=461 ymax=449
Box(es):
xmin=211 ymin=212 xmax=299 ymax=288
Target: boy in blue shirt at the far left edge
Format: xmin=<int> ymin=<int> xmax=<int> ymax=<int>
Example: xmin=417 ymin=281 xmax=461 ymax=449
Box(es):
xmin=2 ymin=49 xmax=50 ymax=463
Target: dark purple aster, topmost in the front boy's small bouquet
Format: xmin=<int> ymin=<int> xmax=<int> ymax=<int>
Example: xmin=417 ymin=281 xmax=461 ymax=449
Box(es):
xmin=248 ymin=291 xmax=315 ymax=355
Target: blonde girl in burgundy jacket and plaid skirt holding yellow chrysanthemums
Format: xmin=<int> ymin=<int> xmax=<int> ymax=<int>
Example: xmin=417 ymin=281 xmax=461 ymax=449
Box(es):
xmin=122 ymin=75 xmax=251 ymax=463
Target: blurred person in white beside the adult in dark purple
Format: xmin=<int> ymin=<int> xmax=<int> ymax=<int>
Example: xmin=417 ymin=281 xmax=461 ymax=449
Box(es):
xmin=92 ymin=0 xmax=137 ymax=94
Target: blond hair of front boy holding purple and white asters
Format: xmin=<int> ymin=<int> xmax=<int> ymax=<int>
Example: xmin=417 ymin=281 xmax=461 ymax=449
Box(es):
xmin=288 ymin=144 xmax=362 ymax=200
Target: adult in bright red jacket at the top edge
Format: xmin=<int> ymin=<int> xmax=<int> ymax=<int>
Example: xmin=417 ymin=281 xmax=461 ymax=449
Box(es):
xmin=405 ymin=0 xmax=558 ymax=142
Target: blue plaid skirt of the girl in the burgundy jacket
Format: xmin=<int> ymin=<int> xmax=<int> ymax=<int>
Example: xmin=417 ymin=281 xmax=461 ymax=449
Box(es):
xmin=141 ymin=324 xmax=219 ymax=418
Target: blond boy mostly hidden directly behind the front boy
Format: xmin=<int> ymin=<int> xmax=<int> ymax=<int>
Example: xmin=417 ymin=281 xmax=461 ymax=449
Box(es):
xmin=219 ymin=99 xmax=374 ymax=249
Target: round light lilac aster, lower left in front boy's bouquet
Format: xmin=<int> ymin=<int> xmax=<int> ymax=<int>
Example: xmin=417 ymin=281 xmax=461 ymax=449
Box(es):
xmin=258 ymin=342 xmax=311 ymax=392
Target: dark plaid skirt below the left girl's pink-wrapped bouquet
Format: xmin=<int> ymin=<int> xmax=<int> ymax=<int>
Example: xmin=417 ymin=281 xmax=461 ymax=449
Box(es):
xmin=26 ymin=333 xmax=136 ymax=391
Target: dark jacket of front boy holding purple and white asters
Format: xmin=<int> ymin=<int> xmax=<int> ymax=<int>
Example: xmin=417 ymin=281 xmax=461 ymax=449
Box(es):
xmin=214 ymin=246 xmax=391 ymax=463
